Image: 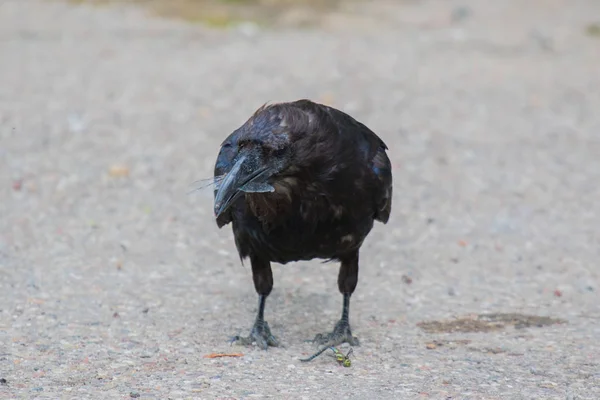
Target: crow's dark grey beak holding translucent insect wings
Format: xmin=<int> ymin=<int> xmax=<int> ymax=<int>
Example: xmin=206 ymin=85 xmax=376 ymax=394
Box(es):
xmin=214 ymin=153 xmax=275 ymax=218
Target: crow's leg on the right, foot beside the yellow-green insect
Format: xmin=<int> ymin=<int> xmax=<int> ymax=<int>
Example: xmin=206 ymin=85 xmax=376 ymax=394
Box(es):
xmin=313 ymin=250 xmax=359 ymax=347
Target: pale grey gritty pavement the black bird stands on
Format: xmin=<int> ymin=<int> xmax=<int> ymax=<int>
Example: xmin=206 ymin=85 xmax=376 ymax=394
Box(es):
xmin=0 ymin=0 xmax=600 ymax=399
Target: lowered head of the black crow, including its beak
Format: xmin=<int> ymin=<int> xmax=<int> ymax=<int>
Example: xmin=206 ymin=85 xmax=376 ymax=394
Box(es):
xmin=214 ymin=106 xmax=302 ymax=220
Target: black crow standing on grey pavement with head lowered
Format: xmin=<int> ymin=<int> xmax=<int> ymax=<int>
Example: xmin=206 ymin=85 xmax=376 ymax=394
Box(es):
xmin=214 ymin=100 xmax=392 ymax=349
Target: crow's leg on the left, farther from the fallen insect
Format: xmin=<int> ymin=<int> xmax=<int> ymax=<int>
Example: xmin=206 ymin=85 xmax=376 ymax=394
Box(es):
xmin=233 ymin=256 xmax=279 ymax=350
